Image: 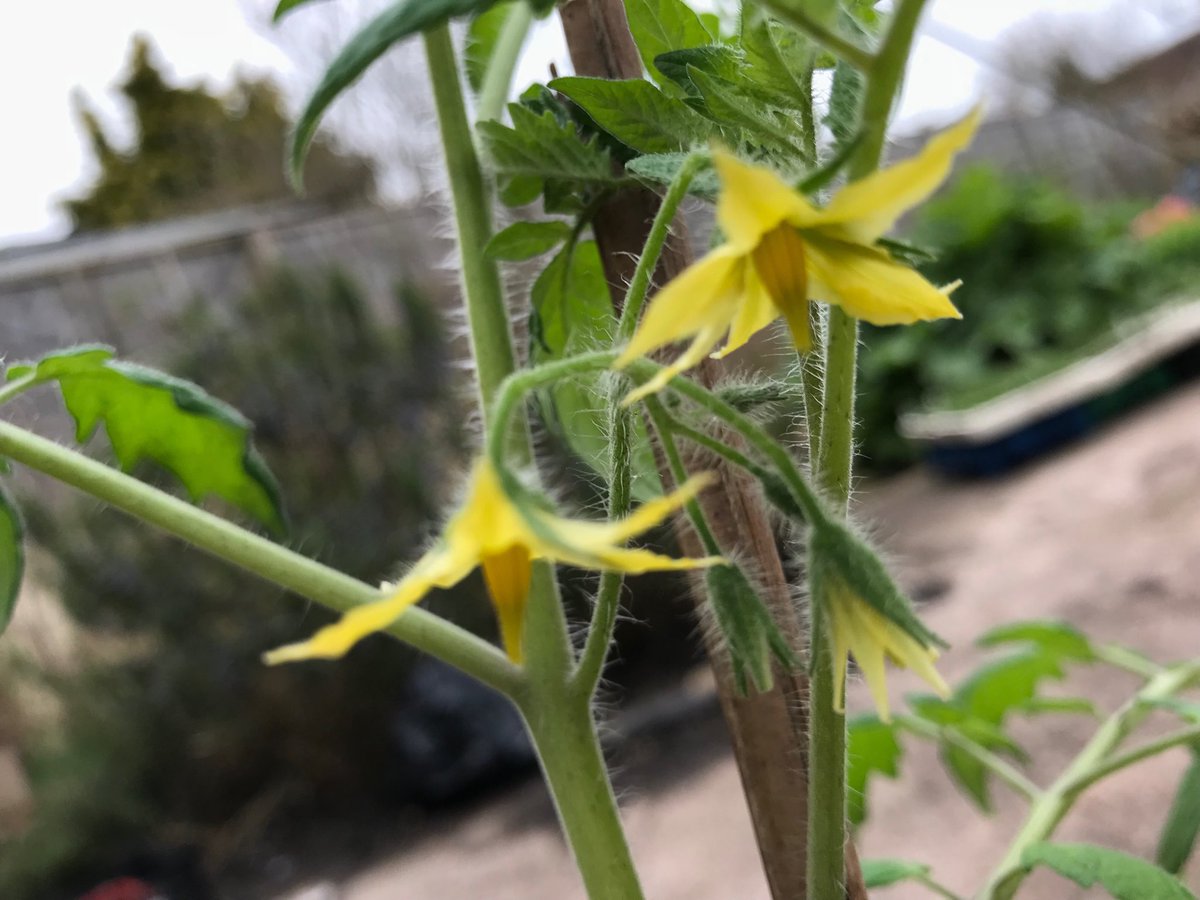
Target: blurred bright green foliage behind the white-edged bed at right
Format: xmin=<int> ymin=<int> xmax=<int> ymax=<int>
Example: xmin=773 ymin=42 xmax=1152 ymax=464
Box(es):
xmin=858 ymin=168 xmax=1200 ymax=469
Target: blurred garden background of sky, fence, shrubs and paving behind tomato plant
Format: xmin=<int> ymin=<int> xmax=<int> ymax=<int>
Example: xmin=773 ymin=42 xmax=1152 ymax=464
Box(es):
xmin=0 ymin=0 xmax=1200 ymax=900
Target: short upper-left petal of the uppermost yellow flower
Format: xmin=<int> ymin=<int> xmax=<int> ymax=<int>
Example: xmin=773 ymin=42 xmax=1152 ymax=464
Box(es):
xmin=713 ymin=150 xmax=823 ymax=253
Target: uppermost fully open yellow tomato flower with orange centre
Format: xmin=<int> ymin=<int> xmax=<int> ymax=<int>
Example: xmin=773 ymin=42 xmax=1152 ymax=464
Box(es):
xmin=616 ymin=108 xmax=979 ymax=403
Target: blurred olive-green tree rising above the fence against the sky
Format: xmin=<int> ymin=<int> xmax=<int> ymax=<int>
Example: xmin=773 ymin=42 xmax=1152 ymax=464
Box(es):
xmin=64 ymin=37 xmax=374 ymax=232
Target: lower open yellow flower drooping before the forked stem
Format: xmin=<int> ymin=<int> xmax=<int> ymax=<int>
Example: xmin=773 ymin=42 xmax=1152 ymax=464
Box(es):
xmin=265 ymin=460 xmax=724 ymax=665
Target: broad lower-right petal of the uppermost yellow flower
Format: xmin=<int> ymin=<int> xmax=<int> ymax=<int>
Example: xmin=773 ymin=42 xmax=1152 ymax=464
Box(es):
xmin=805 ymin=233 xmax=962 ymax=325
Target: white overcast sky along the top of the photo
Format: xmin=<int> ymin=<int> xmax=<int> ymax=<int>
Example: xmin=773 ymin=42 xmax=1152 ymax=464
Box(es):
xmin=0 ymin=0 xmax=1200 ymax=245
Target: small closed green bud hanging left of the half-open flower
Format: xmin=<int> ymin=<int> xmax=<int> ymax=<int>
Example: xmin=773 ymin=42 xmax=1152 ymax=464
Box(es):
xmin=706 ymin=565 xmax=799 ymax=695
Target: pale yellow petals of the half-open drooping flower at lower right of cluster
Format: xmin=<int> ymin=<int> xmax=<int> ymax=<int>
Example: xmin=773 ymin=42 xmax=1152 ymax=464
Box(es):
xmin=822 ymin=578 xmax=950 ymax=722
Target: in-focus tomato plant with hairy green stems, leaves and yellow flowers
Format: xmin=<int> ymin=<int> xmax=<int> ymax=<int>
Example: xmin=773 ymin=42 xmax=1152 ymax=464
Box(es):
xmin=0 ymin=0 xmax=1200 ymax=900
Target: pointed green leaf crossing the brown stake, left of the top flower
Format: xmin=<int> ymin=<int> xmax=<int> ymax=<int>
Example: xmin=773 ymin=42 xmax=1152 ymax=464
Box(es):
xmin=550 ymin=76 xmax=716 ymax=154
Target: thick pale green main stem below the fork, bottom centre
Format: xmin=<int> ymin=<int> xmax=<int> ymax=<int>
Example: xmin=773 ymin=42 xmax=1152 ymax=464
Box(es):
xmin=521 ymin=683 xmax=642 ymax=900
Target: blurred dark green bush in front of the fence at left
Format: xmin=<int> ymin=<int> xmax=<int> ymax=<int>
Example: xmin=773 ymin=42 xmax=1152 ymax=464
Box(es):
xmin=0 ymin=270 xmax=482 ymax=899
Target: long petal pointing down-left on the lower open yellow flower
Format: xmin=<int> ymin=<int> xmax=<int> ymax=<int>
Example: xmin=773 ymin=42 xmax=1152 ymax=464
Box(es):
xmin=263 ymin=550 xmax=465 ymax=666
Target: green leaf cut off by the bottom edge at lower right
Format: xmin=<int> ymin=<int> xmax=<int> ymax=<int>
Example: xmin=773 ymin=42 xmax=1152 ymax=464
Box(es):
xmin=1021 ymin=844 xmax=1195 ymax=900
